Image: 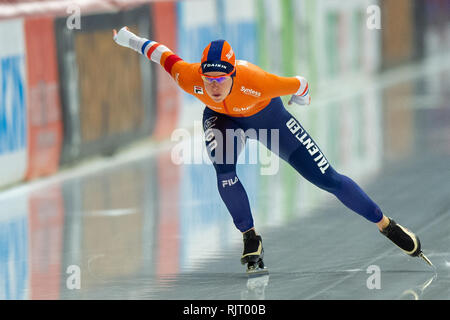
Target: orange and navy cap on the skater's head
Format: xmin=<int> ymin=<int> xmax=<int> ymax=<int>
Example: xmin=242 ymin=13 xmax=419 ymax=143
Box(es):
xmin=200 ymin=40 xmax=236 ymax=75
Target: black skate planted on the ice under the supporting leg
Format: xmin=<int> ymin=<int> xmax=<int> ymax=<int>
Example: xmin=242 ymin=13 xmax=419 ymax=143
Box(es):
xmin=241 ymin=229 xmax=268 ymax=275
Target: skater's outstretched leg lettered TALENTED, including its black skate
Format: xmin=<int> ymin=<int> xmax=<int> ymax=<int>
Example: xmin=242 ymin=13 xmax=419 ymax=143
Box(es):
xmin=239 ymin=98 xmax=432 ymax=266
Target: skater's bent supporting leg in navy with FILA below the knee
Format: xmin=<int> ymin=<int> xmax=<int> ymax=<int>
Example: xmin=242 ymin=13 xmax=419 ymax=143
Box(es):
xmin=203 ymin=109 xmax=254 ymax=232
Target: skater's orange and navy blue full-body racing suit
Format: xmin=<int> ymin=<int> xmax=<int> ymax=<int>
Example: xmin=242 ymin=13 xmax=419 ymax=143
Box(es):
xmin=141 ymin=41 xmax=383 ymax=232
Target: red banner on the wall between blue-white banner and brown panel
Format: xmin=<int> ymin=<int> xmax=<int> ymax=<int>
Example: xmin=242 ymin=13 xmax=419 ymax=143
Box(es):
xmin=25 ymin=18 xmax=62 ymax=179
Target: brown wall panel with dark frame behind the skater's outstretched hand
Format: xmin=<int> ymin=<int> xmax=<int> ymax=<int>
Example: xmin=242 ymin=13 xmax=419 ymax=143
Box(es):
xmin=55 ymin=5 xmax=156 ymax=163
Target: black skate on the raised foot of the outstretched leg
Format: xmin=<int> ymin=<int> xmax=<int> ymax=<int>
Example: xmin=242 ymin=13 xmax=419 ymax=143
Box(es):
xmin=380 ymin=218 xmax=433 ymax=266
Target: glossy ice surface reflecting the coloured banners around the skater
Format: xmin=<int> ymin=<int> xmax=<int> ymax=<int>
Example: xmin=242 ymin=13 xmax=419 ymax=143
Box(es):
xmin=0 ymin=56 xmax=450 ymax=300
